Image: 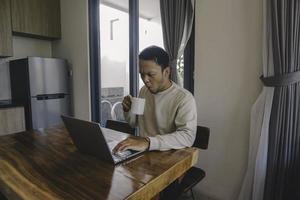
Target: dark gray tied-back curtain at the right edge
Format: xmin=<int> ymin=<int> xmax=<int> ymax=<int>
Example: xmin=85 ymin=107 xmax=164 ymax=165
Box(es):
xmin=262 ymin=0 xmax=300 ymax=200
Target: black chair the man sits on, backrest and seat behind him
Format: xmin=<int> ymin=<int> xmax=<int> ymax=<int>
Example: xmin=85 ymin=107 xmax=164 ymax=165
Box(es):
xmin=180 ymin=126 xmax=210 ymax=199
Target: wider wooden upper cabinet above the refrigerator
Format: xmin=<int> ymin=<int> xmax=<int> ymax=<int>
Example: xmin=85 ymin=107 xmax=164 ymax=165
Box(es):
xmin=11 ymin=0 xmax=61 ymax=39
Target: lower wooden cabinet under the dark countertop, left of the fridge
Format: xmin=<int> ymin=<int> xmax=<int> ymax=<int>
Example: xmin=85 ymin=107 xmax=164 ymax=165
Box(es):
xmin=0 ymin=107 xmax=25 ymax=136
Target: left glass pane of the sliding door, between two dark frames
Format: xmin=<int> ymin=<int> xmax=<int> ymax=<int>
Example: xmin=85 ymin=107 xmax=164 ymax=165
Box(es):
xmin=99 ymin=0 xmax=130 ymax=125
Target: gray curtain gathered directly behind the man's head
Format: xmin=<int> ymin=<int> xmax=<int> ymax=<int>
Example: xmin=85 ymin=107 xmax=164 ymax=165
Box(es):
xmin=160 ymin=0 xmax=194 ymax=82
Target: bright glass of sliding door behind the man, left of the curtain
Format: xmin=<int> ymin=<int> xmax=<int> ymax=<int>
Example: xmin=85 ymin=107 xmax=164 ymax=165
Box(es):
xmin=99 ymin=0 xmax=163 ymax=125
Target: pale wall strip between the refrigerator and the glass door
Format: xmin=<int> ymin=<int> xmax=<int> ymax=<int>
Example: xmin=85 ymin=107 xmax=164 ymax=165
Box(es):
xmin=52 ymin=0 xmax=91 ymax=120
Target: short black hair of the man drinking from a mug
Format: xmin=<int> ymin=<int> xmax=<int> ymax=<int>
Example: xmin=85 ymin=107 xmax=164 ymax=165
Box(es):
xmin=139 ymin=46 xmax=169 ymax=70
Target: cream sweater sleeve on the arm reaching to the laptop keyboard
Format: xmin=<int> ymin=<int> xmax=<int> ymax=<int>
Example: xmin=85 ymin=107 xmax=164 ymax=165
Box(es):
xmin=149 ymin=95 xmax=197 ymax=151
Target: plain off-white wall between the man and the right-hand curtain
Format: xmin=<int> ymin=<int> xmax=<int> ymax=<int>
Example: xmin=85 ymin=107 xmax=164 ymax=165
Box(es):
xmin=195 ymin=0 xmax=262 ymax=200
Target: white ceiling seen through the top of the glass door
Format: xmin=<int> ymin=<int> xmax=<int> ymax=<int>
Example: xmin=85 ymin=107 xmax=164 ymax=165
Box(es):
xmin=100 ymin=0 xmax=160 ymax=21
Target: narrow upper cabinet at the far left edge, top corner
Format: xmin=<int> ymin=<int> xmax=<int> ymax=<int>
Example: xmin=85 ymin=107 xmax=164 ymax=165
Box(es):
xmin=0 ymin=0 xmax=13 ymax=57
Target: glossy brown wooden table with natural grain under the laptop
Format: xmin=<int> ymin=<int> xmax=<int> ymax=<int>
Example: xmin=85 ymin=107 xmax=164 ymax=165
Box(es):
xmin=0 ymin=127 xmax=198 ymax=200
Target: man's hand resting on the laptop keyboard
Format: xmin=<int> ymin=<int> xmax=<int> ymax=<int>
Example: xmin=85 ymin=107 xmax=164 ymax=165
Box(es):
xmin=113 ymin=136 xmax=150 ymax=153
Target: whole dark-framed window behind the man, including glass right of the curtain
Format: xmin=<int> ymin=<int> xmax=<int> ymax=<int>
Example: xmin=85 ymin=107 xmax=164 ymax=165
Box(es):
xmin=89 ymin=0 xmax=193 ymax=122
